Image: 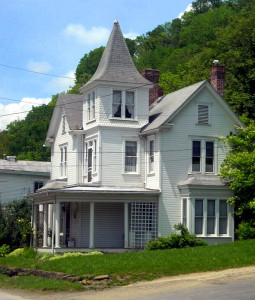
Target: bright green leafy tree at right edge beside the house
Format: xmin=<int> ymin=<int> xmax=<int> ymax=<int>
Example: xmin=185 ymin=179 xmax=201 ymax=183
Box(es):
xmin=220 ymin=121 xmax=255 ymax=236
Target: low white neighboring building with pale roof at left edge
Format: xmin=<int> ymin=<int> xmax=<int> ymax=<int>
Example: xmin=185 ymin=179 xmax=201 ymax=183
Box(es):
xmin=0 ymin=156 xmax=51 ymax=203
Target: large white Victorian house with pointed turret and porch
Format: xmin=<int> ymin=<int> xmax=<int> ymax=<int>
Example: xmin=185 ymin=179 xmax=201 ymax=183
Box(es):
xmin=28 ymin=22 xmax=242 ymax=251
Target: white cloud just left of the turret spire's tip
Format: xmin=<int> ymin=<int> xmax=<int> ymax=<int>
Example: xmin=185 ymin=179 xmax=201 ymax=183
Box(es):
xmin=64 ymin=24 xmax=110 ymax=46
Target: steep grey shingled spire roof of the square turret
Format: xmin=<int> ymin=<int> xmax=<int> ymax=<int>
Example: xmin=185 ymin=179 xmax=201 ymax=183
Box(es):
xmin=80 ymin=21 xmax=152 ymax=92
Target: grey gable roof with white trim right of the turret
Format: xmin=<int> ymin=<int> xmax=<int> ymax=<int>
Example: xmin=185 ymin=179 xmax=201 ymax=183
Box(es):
xmin=142 ymin=80 xmax=243 ymax=133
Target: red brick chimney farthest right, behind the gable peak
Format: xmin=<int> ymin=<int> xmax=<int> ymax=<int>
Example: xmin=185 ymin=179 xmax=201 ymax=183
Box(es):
xmin=211 ymin=60 xmax=225 ymax=98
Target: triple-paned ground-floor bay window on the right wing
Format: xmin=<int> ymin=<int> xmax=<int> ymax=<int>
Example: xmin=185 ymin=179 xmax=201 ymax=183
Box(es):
xmin=193 ymin=198 xmax=229 ymax=236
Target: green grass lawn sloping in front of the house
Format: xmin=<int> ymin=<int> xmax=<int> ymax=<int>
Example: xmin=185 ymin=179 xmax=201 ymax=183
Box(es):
xmin=0 ymin=240 xmax=255 ymax=290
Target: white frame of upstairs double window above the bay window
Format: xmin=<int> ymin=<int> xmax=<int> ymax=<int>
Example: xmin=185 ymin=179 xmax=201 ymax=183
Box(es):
xmin=190 ymin=137 xmax=218 ymax=174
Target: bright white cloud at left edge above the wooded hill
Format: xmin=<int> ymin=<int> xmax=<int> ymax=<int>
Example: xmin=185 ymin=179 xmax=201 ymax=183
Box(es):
xmin=0 ymin=97 xmax=51 ymax=130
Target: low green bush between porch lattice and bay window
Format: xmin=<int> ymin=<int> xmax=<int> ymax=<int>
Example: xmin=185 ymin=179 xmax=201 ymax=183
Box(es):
xmin=146 ymin=223 xmax=207 ymax=250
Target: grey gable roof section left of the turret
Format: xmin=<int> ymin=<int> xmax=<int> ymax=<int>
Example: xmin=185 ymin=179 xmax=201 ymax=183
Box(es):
xmin=45 ymin=94 xmax=83 ymax=146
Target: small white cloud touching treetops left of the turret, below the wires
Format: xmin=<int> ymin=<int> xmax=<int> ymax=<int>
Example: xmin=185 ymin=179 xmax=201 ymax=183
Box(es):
xmin=46 ymin=71 xmax=75 ymax=94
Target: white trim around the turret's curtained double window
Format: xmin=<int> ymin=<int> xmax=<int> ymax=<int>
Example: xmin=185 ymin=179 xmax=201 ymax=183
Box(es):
xmin=110 ymin=88 xmax=137 ymax=121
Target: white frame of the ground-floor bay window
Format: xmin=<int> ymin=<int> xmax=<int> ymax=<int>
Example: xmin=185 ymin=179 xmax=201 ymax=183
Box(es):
xmin=190 ymin=197 xmax=232 ymax=237
